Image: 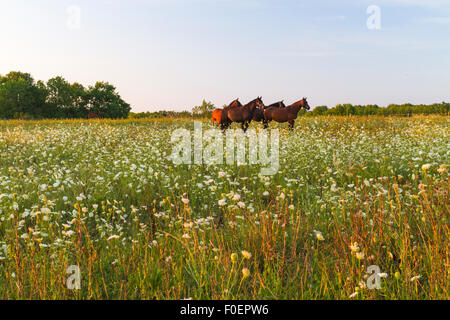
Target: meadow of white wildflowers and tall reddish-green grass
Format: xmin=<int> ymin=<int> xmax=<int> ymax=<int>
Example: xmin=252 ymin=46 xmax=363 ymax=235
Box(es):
xmin=0 ymin=117 xmax=450 ymax=299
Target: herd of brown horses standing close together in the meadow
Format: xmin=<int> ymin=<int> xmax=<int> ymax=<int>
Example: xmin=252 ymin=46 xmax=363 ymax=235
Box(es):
xmin=212 ymin=97 xmax=310 ymax=132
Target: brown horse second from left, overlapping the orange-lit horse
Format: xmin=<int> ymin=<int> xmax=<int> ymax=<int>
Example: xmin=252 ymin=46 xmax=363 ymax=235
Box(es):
xmin=220 ymin=97 xmax=264 ymax=132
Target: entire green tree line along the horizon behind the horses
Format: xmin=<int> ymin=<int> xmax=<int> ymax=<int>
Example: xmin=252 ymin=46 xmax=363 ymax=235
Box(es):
xmin=0 ymin=71 xmax=450 ymax=119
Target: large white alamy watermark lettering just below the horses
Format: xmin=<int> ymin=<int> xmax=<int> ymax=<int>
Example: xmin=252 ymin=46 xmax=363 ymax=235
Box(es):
xmin=170 ymin=121 xmax=280 ymax=176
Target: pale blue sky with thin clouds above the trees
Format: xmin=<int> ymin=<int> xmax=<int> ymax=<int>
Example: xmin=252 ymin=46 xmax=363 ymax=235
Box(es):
xmin=0 ymin=0 xmax=450 ymax=112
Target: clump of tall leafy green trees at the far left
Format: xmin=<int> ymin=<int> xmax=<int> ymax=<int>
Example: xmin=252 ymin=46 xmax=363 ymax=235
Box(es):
xmin=0 ymin=71 xmax=131 ymax=119
